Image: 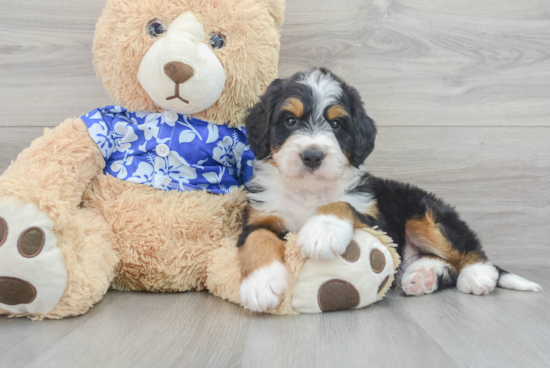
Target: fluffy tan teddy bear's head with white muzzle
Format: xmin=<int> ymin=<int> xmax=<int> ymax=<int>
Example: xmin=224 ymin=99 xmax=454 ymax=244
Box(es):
xmin=93 ymin=0 xmax=284 ymax=126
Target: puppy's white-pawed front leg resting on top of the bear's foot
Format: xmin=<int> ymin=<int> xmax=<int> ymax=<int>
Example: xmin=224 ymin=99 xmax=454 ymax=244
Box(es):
xmin=296 ymin=202 xmax=364 ymax=260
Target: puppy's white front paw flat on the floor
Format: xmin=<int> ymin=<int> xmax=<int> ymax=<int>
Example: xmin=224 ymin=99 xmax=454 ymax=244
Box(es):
xmin=241 ymin=261 xmax=288 ymax=312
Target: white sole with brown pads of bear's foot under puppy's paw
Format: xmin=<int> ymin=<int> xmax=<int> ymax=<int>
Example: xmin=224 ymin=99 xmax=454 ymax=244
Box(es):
xmin=292 ymin=230 xmax=394 ymax=313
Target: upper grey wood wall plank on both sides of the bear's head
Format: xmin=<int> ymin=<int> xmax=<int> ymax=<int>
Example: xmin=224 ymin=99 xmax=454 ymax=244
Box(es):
xmin=0 ymin=0 xmax=550 ymax=126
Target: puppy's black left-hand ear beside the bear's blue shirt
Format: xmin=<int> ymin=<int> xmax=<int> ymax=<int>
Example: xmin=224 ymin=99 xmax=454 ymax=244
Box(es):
xmin=245 ymin=79 xmax=283 ymax=160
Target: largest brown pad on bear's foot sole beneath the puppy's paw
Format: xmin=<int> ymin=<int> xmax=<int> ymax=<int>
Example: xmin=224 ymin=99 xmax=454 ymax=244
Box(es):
xmin=318 ymin=279 xmax=361 ymax=312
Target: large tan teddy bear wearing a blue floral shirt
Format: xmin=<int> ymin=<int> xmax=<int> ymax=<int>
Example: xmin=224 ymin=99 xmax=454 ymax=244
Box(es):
xmin=0 ymin=0 xmax=399 ymax=320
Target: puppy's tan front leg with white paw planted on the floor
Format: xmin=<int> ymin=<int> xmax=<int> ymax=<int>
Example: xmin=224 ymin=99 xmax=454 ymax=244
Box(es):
xmin=238 ymin=211 xmax=288 ymax=312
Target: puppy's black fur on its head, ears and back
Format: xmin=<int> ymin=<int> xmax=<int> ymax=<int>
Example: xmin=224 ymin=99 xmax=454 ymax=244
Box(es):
xmin=245 ymin=69 xmax=532 ymax=289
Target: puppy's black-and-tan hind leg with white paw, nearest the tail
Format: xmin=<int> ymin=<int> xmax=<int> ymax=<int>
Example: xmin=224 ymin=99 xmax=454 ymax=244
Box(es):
xmin=405 ymin=208 xmax=499 ymax=295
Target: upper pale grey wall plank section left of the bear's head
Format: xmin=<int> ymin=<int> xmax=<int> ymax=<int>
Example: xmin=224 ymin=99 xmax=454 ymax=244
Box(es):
xmin=0 ymin=0 xmax=113 ymax=127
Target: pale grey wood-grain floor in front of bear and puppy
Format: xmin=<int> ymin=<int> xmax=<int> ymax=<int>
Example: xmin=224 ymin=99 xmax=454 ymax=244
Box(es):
xmin=0 ymin=268 xmax=550 ymax=368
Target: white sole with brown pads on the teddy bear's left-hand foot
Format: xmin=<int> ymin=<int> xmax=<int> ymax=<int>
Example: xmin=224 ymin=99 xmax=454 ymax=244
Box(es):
xmin=0 ymin=198 xmax=67 ymax=314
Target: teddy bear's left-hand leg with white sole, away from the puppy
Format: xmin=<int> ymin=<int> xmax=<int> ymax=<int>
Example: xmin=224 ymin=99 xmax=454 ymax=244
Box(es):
xmin=0 ymin=204 xmax=119 ymax=319
